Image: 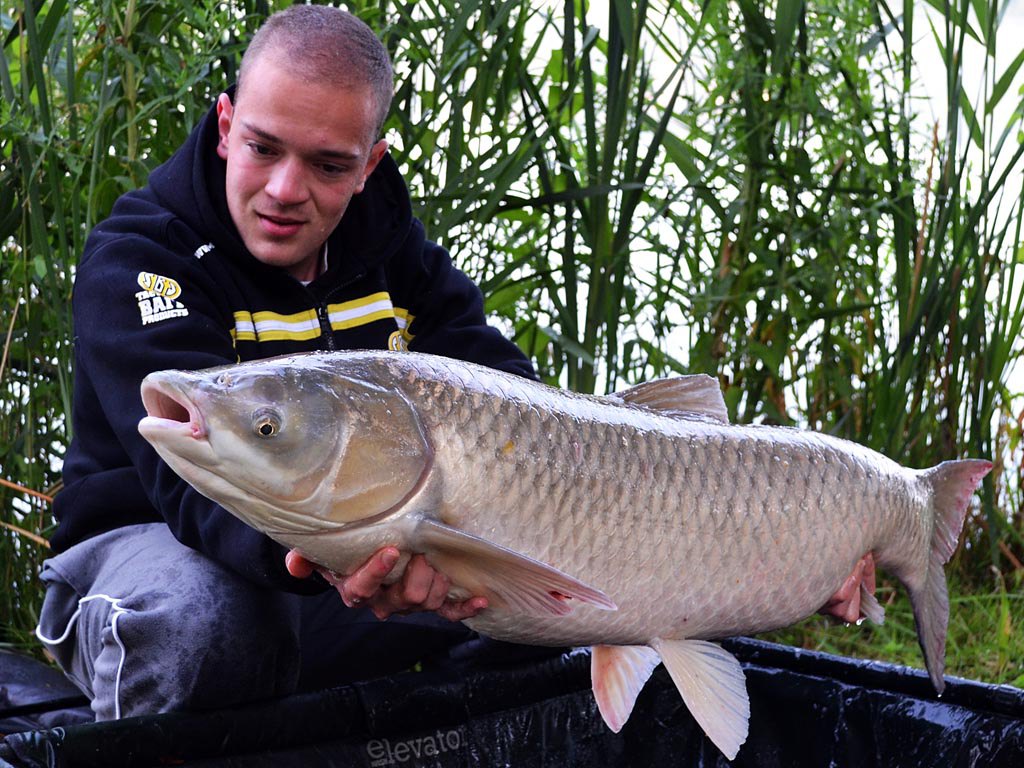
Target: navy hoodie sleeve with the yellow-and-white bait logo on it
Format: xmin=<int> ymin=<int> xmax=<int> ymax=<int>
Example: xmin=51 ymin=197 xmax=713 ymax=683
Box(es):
xmin=64 ymin=210 xmax=325 ymax=593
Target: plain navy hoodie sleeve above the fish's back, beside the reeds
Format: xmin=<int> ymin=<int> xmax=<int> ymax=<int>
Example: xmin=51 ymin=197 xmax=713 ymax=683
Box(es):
xmin=391 ymin=222 xmax=537 ymax=379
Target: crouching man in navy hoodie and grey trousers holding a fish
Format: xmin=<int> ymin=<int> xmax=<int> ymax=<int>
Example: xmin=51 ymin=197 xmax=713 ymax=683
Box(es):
xmin=37 ymin=5 xmax=872 ymax=720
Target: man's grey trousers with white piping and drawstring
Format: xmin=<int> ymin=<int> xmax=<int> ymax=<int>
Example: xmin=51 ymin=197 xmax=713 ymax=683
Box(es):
xmin=36 ymin=523 xmax=474 ymax=720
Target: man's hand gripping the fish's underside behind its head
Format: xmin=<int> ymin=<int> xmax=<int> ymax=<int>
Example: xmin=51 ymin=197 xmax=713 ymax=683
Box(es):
xmin=285 ymin=547 xmax=487 ymax=622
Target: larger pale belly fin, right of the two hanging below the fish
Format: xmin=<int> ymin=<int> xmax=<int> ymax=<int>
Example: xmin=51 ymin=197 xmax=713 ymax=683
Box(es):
xmin=651 ymin=640 xmax=751 ymax=760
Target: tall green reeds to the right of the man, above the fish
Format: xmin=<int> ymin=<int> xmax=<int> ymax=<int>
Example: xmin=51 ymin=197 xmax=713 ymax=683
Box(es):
xmin=394 ymin=0 xmax=1024 ymax=585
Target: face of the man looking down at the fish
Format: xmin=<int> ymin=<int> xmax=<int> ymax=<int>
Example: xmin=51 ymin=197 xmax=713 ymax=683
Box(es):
xmin=217 ymin=53 xmax=387 ymax=281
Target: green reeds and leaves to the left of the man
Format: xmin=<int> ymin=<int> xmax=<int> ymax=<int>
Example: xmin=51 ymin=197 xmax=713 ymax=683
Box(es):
xmin=0 ymin=0 xmax=260 ymax=644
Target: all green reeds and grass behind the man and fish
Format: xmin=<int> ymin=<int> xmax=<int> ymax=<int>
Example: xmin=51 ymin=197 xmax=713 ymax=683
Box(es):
xmin=0 ymin=0 xmax=1024 ymax=682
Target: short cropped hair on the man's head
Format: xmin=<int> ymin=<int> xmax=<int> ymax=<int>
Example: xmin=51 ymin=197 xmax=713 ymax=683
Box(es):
xmin=236 ymin=5 xmax=394 ymax=139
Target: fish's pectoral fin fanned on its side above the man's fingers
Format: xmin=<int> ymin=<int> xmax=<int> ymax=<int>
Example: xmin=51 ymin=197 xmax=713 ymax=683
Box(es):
xmin=413 ymin=519 xmax=617 ymax=616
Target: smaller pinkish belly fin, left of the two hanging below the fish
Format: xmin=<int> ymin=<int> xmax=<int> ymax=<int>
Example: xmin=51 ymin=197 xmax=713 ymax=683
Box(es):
xmin=590 ymin=645 xmax=662 ymax=733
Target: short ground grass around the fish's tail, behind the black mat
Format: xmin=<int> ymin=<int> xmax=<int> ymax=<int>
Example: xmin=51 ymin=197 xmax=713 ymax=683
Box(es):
xmin=759 ymin=571 xmax=1024 ymax=687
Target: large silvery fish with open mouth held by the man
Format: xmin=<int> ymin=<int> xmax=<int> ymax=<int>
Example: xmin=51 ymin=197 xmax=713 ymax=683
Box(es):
xmin=139 ymin=351 xmax=991 ymax=759
